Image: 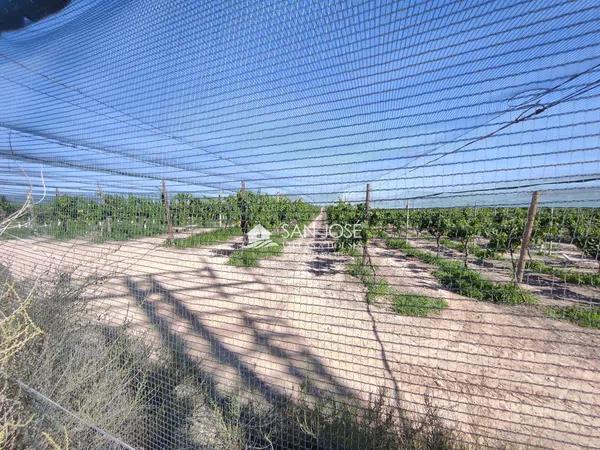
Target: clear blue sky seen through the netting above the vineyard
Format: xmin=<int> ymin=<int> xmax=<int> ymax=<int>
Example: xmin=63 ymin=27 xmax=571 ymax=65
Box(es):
xmin=0 ymin=0 xmax=600 ymax=207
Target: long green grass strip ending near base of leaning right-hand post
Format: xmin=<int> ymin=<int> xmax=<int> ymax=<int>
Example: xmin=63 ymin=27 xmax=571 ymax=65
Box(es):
xmin=386 ymin=239 xmax=537 ymax=305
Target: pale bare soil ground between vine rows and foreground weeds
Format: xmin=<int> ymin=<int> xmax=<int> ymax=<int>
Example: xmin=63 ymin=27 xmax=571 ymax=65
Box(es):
xmin=0 ymin=216 xmax=600 ymax=449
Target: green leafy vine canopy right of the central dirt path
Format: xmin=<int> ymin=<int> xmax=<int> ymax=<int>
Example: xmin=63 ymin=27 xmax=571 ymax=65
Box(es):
xmin=327 ymin=202 xmax=600 ymax=273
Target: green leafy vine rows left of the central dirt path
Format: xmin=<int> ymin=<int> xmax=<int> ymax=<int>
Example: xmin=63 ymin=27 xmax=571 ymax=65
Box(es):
xmin=0 ymin=192 xmax=318 ymax=242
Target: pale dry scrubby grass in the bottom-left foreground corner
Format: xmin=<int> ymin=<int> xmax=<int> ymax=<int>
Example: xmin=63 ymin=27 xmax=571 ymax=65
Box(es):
xmin=0 ymin=270 xmax=158 ymax=449
